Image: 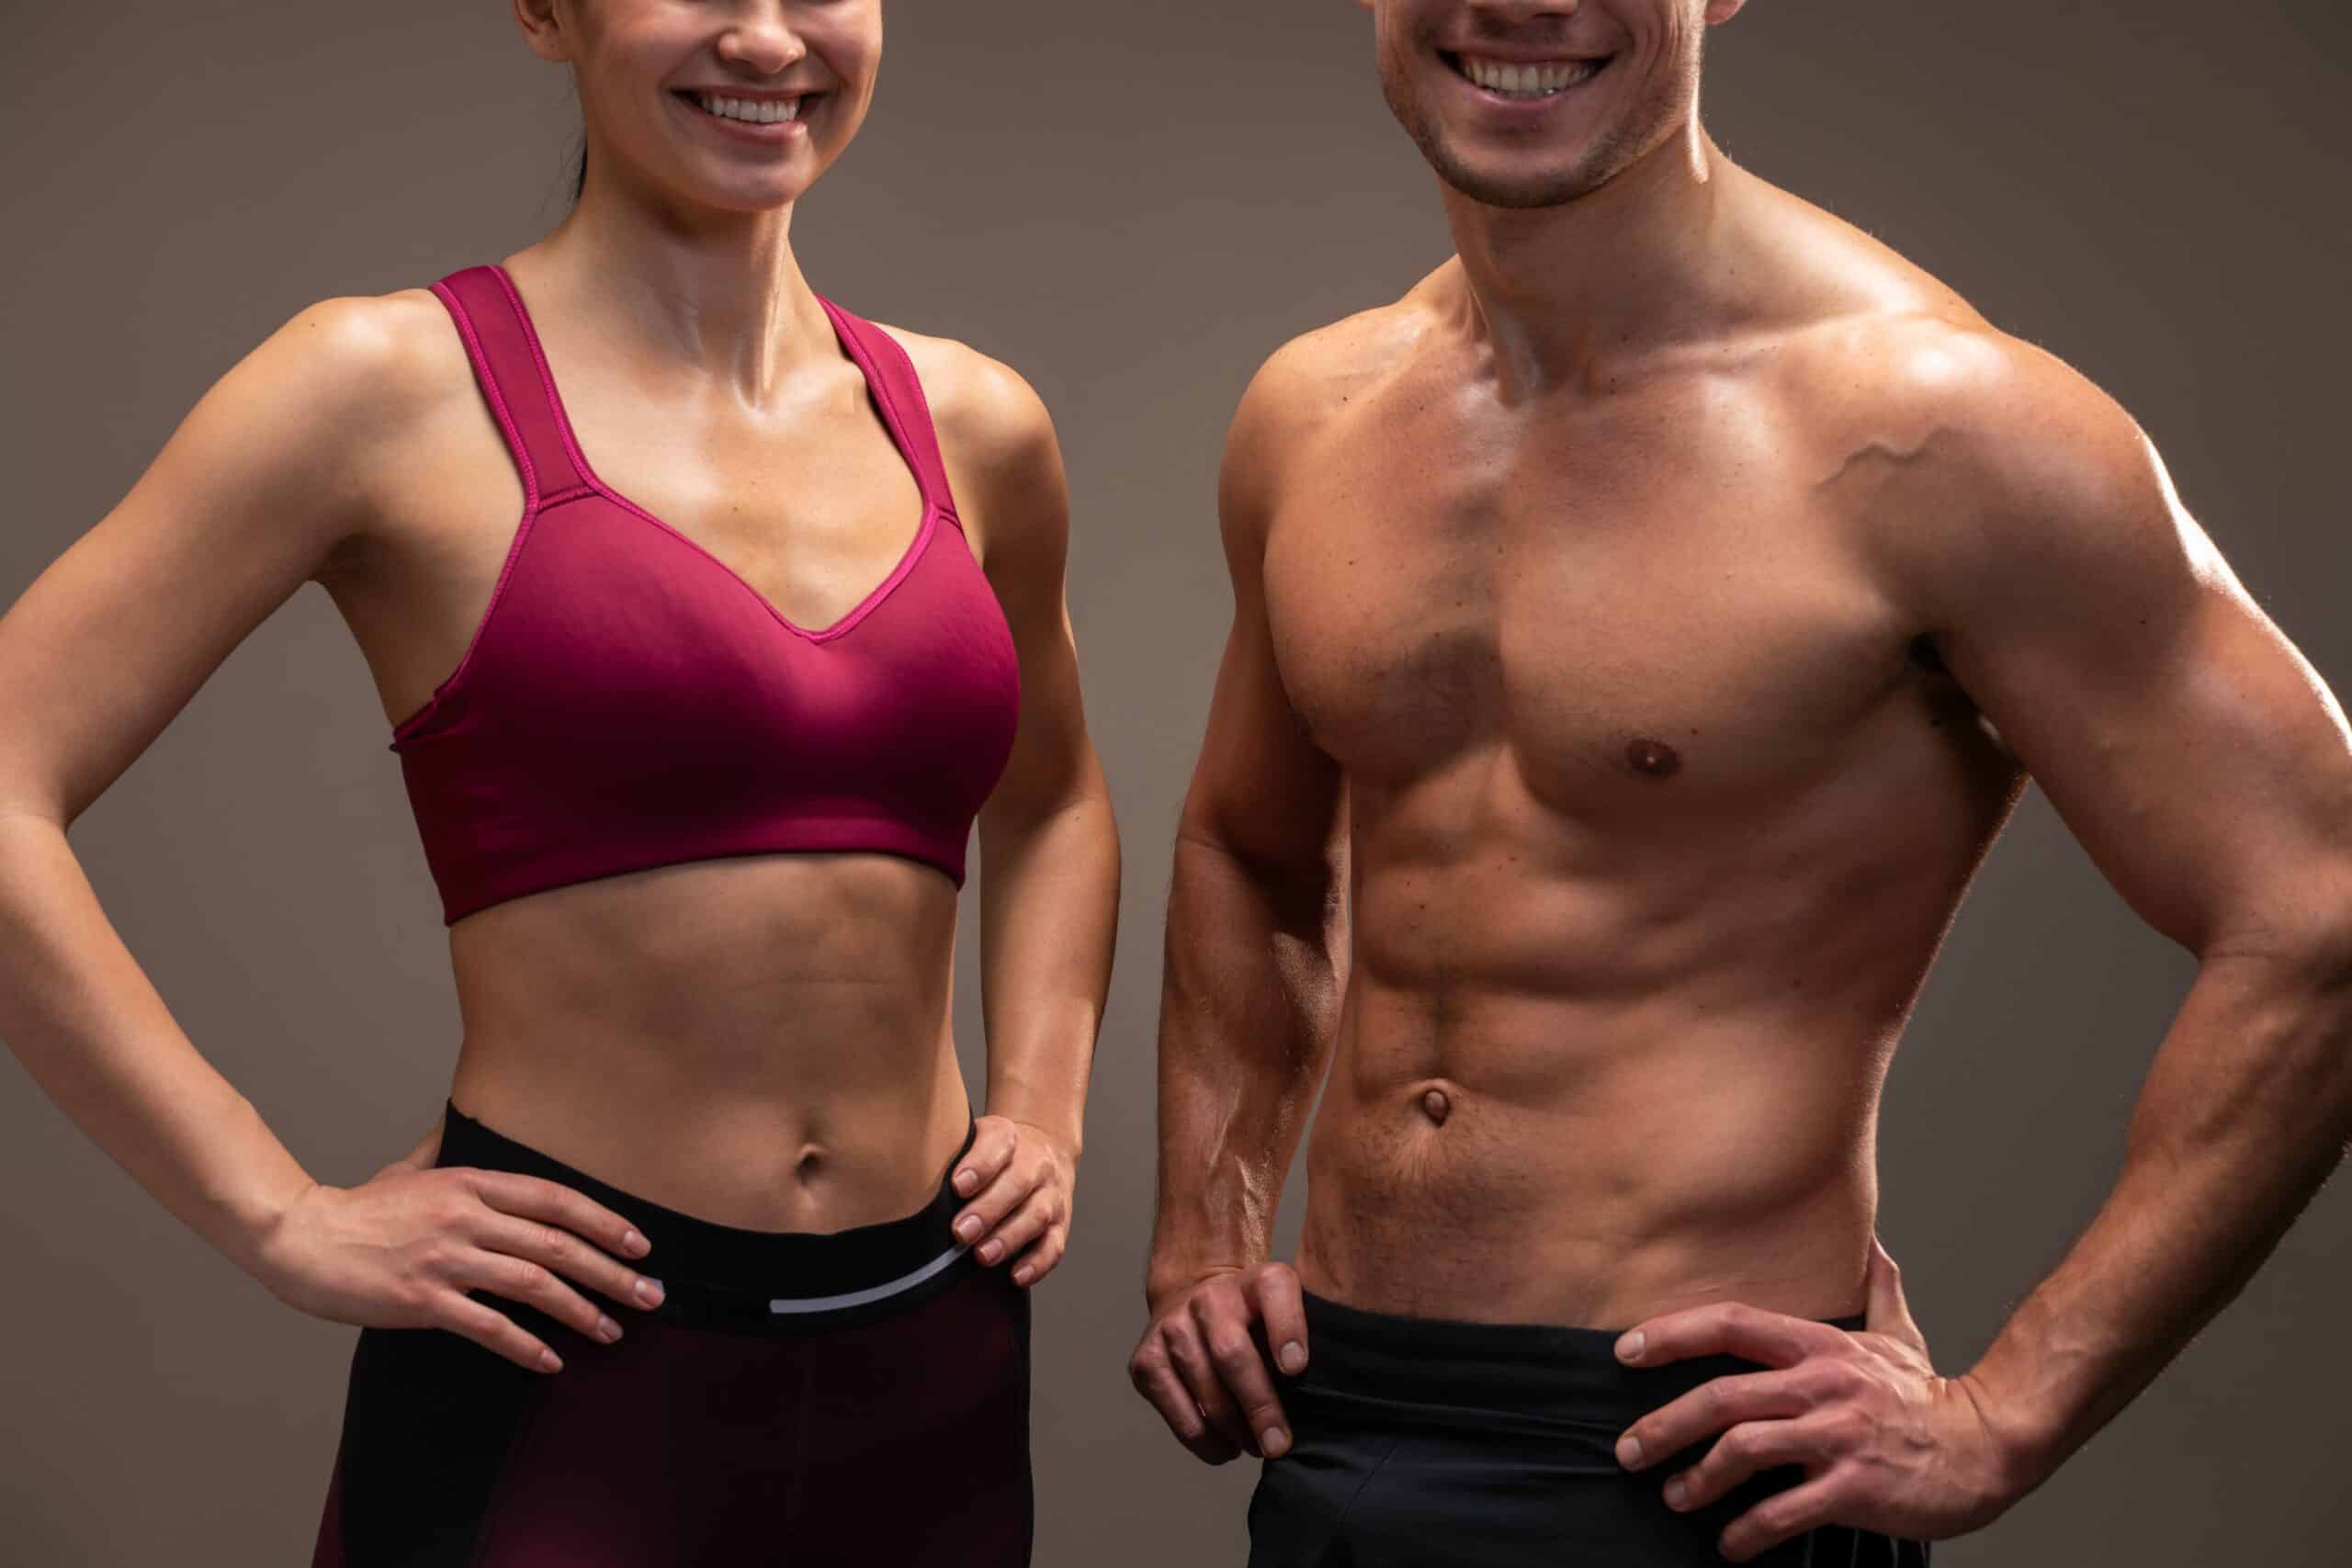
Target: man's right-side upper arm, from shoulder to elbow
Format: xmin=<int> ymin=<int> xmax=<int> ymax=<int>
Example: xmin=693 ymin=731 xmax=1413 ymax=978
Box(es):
xmin=1936 ymin=373 xmax=2352 ymax=952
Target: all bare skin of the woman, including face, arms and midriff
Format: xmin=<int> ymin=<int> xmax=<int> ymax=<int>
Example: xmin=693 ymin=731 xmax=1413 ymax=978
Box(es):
xmin=0 ymin=0 xmax=1117 ymax=1371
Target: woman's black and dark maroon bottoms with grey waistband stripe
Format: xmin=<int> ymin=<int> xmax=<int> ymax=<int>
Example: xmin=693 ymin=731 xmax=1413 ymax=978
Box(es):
xmin=312 ymin=1105 xmax=1033 ymax=1568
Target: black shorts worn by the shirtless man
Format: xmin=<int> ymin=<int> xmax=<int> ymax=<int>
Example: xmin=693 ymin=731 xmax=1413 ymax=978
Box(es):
xmin=1249 ymin=1291 xmax=1927 ymax=1568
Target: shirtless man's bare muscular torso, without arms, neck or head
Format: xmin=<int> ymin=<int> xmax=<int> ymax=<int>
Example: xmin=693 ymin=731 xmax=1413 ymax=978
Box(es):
xmin=1265 ymin=176 xmax=2023 ymax=1325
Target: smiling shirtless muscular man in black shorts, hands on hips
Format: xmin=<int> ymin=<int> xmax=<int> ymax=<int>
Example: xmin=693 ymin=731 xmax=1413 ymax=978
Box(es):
xmin=1129 ymin=0 xmax=2352 ymax=1568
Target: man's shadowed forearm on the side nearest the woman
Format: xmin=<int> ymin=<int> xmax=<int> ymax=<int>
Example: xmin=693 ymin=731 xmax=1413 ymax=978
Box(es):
xmin=1143 ymin=837 xmax=1345 ymax=1307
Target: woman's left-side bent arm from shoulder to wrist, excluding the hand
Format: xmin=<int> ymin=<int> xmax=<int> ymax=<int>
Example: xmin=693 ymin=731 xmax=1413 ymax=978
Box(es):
xmin=0 ymin=299 xmax=398 ymax=1272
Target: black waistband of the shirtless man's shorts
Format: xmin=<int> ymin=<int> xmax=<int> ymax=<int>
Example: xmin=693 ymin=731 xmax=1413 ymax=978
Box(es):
xmin=1284 ymin=1291 xmax=1863 ymax=1427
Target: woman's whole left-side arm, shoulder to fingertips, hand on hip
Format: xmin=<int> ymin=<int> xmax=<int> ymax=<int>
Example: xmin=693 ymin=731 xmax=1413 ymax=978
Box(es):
xmin=0 ymin=299 xmax=659 ymax=1371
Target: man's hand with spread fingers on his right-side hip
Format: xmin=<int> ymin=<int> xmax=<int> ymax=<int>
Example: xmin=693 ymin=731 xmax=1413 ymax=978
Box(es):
xmin=1618 ymin=1236 xmax=2020 ymax=1563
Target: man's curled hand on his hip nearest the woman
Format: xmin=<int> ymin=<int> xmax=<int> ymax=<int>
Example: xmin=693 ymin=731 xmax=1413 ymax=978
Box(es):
xmin=1126 ymin=1262 xmax=1307 ymax=1464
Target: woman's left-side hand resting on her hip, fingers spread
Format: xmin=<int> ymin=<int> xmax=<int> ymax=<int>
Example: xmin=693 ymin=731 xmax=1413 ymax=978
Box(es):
xmin=261 ymin=1152 xmax=661 ymax=1373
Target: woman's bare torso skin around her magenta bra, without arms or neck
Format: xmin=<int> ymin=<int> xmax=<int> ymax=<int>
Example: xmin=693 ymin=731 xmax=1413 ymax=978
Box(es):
xmin=322 ymin=254 xmax=978 ymax=1229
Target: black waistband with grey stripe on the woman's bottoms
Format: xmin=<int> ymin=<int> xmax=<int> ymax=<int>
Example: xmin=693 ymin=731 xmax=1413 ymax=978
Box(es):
xmin=433 ymin=1100 xmax=978 ymax=1333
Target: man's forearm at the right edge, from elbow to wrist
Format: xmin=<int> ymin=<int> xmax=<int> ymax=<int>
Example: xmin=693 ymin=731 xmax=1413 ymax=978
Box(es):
xmin=1966 ymin=952 xmax=2352 ymax=1495
